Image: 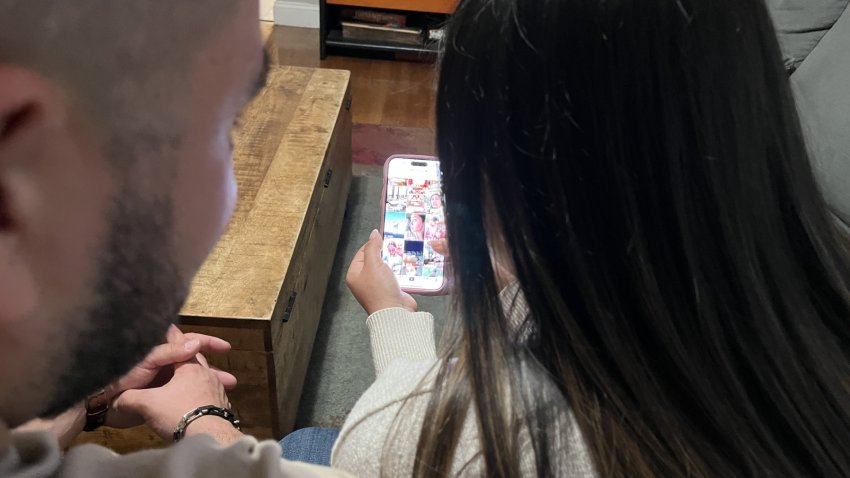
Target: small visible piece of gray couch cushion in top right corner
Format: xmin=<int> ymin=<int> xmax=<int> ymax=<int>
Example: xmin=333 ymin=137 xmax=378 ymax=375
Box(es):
xmin=767 ymin=0 xmax=850 ymax=71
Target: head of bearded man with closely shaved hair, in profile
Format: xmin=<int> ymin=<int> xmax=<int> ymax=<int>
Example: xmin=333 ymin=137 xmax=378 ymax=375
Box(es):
xmin=0 ymin=0 xmax=264 ymax=426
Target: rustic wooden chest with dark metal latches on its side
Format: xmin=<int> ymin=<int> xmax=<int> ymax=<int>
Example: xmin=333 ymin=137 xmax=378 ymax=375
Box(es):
xmin=81 ymin=67 xmax=351 ymax=452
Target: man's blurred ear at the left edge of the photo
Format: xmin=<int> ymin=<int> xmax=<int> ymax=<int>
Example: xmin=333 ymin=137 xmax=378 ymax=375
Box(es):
xmin=0 ymin=65 xmax=57 ymax=326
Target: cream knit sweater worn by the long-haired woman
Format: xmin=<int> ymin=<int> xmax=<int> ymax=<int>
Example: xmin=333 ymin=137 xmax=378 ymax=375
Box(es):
xmin=331 ymin=289 xmax=595 ymax=477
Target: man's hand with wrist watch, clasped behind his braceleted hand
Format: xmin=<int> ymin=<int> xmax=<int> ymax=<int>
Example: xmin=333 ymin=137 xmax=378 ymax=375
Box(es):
xmin=106 ymin=325 xmax=236 ymax=428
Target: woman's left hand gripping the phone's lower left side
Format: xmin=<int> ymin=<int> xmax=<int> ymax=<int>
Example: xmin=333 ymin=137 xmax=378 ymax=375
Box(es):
xmin=345 ymin=230 xmax=417 ymax=315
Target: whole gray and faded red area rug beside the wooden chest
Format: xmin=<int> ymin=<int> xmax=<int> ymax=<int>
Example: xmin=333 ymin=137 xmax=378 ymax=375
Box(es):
xmin=296 ymin=124 xmax=449 ymax=428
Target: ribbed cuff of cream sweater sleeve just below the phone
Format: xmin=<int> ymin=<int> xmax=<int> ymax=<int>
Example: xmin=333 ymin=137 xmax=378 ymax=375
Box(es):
xmin=366 ymin=307 xmax=437 ymax=377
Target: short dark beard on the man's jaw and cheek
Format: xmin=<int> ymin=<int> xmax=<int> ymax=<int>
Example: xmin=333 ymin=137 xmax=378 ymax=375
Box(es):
xmin=42 ymin=191 xmax=188 ymax=416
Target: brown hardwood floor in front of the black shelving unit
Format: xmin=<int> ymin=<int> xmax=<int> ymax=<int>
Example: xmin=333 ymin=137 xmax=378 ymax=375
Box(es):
xmin=264 ymin=25 xmax=436 ymax=128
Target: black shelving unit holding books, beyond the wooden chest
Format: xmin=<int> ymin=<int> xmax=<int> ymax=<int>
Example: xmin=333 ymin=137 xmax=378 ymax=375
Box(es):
xmin=319 ymin=0 xmax=448 ymax=61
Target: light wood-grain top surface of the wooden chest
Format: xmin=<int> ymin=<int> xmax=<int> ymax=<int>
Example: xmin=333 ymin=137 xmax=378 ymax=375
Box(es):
xmin=181 ymin=66 xmax=349 ymax=323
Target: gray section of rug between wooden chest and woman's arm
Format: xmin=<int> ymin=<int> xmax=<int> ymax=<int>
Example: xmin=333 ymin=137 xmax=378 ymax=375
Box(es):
xmin=296 ymin=165 xmax=448 ymax=428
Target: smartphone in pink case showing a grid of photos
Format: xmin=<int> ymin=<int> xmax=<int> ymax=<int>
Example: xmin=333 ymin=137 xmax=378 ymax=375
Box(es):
xmin=381 ymin=155 xmax=446 ymax=295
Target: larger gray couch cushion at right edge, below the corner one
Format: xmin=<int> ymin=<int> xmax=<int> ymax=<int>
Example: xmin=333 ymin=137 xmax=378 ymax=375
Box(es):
xmin=791 ymin=3 xmax=850 ymax=228
